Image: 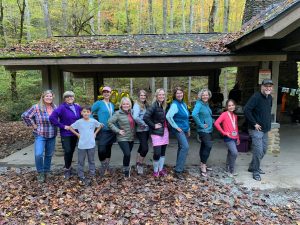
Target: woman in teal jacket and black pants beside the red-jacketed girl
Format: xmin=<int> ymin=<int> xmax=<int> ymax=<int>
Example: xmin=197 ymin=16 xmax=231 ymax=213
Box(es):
xmin=192 ymin=88 xmax=213 ymax=177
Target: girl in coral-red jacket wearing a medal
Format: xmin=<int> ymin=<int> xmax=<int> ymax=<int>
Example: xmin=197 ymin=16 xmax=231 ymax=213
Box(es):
xmin=214 ymin=99 xmax=240 ymax=176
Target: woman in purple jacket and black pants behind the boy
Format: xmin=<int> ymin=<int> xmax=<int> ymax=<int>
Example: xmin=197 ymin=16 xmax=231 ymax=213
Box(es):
xmin=50 ymin=91 xmax=81 ymax=179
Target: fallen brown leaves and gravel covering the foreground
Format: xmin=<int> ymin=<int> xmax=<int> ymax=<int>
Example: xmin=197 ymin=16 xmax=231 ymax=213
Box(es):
xmin=0 ymin=167 xmax=300 ymax=225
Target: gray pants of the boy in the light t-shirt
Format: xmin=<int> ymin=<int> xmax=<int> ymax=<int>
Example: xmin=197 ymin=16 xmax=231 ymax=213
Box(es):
xmin=77 ymin=148 xmax=95 ymax=178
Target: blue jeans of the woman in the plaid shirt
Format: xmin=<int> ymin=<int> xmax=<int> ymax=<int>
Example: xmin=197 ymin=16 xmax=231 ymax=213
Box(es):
xmin=34 ymin=135 xmax=55 ymax=173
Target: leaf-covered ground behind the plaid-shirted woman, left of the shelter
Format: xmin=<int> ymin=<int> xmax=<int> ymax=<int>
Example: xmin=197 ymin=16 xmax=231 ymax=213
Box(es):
xmin=0 ymin=121 xmax=33 ymax=159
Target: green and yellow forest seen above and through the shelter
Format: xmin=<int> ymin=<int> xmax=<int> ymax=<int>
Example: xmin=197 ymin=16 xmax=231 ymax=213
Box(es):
xmin=0 ymin=0 xmax=296 ymax=121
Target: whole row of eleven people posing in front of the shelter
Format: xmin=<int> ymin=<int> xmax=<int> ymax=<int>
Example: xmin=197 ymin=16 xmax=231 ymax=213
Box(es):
xmin=22 ymin=80 xmax=273 ymax=184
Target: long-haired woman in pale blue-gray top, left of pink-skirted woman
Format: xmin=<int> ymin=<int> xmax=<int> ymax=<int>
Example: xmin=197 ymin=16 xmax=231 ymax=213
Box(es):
xmin=133 ymin=90 xmax=149 ymax=175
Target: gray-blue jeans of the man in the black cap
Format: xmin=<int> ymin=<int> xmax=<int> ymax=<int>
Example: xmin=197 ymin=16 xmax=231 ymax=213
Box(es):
xmin=249 ymin=130 xmax=268 ymax=174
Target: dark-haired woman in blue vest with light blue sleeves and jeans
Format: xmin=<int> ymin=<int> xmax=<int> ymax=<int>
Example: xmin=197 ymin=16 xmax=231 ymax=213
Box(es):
xmin=166 ymin=87 xmax=190 ymax=179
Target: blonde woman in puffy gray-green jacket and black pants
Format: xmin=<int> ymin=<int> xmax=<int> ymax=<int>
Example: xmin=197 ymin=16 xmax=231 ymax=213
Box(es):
xmin=108 ymin=97 xmax=135 ymax=177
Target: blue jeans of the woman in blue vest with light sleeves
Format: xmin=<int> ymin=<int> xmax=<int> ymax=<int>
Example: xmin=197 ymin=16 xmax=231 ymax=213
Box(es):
xmin=174 ymin=131 xmax=189 ymax=173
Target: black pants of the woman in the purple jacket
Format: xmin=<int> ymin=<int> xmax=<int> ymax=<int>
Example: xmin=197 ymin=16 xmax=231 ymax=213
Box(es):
xmin=61 ymin=136 xmax=78 ymax=169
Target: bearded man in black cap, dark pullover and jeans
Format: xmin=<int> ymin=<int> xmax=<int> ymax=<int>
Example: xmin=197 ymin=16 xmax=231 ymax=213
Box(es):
xmin=244 ymin=79 xmax=273 ymax=181
